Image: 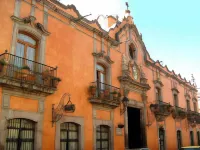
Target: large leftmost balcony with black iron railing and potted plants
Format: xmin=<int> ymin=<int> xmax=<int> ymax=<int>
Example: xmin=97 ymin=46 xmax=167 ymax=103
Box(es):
xmin=0 ymin=52 xmax=60 ymax=94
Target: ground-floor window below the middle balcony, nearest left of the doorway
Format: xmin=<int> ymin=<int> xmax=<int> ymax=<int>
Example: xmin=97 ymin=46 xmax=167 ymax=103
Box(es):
xmin=96 ymin=125 xmax=110 ymax=150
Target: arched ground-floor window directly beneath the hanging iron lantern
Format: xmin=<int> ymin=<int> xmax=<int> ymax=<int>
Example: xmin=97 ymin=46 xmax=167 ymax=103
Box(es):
xmin=60 ymin=123 xmax=79 ymax=150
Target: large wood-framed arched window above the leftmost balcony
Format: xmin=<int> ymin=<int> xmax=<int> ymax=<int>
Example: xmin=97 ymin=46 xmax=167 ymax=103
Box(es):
xmin=15 ymin=33 xmax=37 ymax=69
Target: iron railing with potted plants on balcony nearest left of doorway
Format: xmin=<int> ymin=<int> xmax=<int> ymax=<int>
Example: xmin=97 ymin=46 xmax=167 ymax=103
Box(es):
xmin=91 ymin=81 xmax=121 ymax=101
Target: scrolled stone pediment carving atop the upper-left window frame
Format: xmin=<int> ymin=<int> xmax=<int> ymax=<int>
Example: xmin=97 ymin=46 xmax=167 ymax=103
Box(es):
xmin=11 ymin=15 xmax=51 ymax=36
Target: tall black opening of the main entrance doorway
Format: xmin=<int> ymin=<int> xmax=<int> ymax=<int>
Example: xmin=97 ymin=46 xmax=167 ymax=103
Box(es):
xmin=128 ymin=107 xmax=143 ymax=148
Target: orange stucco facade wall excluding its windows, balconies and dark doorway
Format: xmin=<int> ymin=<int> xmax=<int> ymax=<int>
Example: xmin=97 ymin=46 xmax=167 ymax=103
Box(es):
xmin=0 ymin=0 xmax=200 ymax=150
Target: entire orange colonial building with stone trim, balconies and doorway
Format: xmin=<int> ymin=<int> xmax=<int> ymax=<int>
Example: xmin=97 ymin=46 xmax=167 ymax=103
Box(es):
xmin=0 ymin=0 xmax=200 ymax=150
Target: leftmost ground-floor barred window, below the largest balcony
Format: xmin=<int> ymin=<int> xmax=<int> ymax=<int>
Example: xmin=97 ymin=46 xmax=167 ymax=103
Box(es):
xmin=6 ymin=119 xmax=35 ymax=150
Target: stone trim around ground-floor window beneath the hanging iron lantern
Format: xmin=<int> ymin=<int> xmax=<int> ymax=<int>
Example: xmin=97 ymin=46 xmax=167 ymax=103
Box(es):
xmin=55 ymin=116 xmax=84 ymax=150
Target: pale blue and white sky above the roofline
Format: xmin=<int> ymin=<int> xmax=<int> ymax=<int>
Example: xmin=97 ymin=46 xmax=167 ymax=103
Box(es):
xmin=60 ymin=0 xmax=200 ymax=92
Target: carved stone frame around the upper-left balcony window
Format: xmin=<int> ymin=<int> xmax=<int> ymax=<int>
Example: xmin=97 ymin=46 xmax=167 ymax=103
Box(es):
xmin=10 ymin=16 xmax=50 ymax=63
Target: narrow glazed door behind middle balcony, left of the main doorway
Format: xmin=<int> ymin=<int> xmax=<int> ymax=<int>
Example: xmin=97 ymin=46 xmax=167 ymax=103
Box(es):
xmin=96 ymin=64 xmax=106 ymax=91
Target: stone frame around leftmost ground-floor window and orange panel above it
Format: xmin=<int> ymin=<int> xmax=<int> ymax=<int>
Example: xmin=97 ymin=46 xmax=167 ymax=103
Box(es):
xmin=0 ymin=89 xmax=45 ymax=150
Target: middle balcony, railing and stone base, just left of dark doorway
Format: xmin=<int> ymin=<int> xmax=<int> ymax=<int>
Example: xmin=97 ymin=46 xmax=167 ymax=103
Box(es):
xmin=89 ymin=81 xmax=121 ymax=108
